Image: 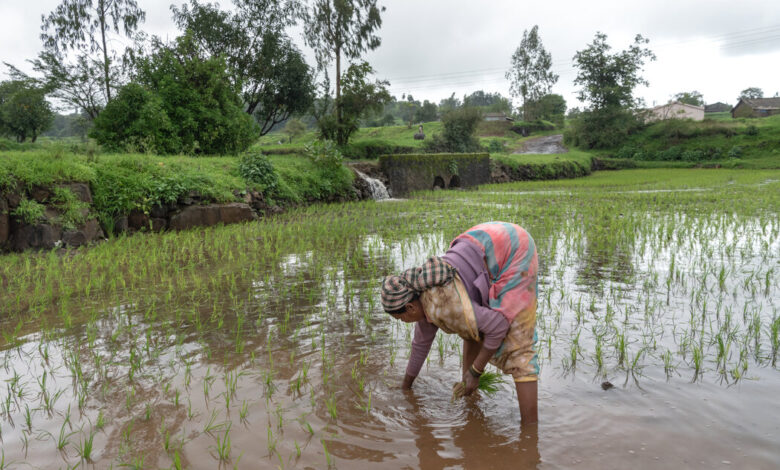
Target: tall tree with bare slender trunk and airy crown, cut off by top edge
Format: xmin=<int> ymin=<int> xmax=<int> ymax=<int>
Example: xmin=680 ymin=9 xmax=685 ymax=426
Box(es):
xmin=303 ymin=0 xmax=385 ymax=135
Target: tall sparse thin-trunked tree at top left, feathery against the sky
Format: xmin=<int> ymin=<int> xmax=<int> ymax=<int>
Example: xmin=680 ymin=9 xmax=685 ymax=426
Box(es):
xmin=41 ymin=0 xmax=146 ymax=102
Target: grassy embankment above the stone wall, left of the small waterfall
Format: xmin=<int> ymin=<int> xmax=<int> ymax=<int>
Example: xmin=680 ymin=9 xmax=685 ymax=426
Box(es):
xmin=0 ymin=150 xmax=352 ymax=231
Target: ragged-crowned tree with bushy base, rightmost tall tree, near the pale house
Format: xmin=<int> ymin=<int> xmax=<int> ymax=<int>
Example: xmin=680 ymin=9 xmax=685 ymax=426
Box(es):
xmin=564 ymin=32 xmax=655 ymax=148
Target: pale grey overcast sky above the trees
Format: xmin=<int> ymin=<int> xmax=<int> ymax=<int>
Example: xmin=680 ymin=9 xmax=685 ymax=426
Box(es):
xmin=0 ymin=0 xmax=780 ymax=111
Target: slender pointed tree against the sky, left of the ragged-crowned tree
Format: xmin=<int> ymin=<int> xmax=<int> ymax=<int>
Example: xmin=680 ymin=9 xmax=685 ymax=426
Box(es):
xmin=506 ymin=25 xmax=558 ymax=121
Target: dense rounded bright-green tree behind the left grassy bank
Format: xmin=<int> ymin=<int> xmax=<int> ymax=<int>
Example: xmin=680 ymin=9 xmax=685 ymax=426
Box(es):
xmin=90 ymin=35 xmax=257 ymax=154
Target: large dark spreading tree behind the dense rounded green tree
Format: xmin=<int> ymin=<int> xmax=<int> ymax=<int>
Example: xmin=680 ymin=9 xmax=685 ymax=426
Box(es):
xmin=172 ymin=0 xmax=314 ymax=135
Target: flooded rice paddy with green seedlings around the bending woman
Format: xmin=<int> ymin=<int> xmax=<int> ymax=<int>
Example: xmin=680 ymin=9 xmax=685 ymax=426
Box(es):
xmin=0 ymin=170 xmax=780 ymax=469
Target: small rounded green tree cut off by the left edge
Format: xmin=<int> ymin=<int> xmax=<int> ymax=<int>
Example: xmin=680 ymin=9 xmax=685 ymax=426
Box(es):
xmin=0 ymin=80 xmax=54 ymax=142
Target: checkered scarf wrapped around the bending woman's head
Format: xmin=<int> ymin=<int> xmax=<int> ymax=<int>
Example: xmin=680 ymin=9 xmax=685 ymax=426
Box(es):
xmin=382 ymin=256 xmax=457 ymax=312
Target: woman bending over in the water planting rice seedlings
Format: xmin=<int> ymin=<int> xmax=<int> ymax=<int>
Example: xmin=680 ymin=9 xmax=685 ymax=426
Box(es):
xmin=382 ymin=222 xmax=539 ymax=424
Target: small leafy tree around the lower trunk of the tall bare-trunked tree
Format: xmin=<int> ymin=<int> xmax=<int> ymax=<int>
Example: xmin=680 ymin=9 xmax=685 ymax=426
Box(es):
xmin=317 ymin=62 xmax=390 ymax=145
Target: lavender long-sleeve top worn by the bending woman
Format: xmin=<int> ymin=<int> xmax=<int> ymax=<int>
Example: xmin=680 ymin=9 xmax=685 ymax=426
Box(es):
xmin=406 ymin=239 xmax=509 ymax=377
